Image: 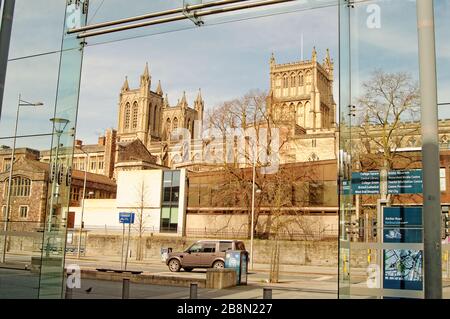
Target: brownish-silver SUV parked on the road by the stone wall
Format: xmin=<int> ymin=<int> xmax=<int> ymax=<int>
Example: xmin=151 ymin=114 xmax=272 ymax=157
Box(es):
xmin=166 ymin=240 xmax=245 ymax=272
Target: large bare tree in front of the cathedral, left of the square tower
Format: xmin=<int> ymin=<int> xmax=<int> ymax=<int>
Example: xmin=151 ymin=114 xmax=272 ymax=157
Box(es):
xmin=206 ymin=91 xmax=287 ymax=237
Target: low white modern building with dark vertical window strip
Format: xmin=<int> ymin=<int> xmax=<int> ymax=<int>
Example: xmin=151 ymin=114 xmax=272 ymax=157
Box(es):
xmin=69 ymin=169 xmax=187 ymax=236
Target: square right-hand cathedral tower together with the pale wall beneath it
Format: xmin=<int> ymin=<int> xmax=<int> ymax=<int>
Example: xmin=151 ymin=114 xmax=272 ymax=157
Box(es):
xmin=267 ymin=48 xmax=338 ymax=163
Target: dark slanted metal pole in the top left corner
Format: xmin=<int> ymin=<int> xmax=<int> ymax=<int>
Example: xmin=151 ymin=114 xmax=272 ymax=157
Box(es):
xmin=0 ymin=0 xmax=16 ymax=118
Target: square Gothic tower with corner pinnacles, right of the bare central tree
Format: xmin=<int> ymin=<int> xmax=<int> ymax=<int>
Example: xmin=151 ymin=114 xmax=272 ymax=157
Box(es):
xmin=268 ymin=48 xmax=336 ymax=134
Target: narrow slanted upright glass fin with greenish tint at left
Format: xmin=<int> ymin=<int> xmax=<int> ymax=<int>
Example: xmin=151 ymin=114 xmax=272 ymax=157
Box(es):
xmin=39 ymin=1 xmax=87 ymax=298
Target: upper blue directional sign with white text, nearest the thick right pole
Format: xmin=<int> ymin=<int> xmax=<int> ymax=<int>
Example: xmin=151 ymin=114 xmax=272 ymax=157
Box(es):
xmin=388 ymin=169 xmax=423 ymax=194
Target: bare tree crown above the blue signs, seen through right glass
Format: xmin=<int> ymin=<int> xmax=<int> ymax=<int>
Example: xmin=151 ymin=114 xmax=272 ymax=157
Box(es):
xmin=352 ymin=70 xmax=420 ymax=201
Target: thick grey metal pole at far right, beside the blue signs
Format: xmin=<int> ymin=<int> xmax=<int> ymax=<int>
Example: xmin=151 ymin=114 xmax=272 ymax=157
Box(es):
xmin=417 ymin=0 xmax=442 ymax=299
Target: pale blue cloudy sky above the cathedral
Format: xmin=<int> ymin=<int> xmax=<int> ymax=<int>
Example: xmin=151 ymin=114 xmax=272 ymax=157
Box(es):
xmin=0 ymin=0 xmax=450 ymax=148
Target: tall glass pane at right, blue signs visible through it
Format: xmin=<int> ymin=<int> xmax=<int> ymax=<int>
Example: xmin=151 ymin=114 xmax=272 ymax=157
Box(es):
xmin=339 ymin=0 xmax=449 ymax=298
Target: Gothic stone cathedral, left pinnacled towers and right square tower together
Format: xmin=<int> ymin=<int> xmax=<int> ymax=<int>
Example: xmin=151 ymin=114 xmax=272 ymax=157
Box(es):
xmin=57 ymin=49 xmax=338 ymax=178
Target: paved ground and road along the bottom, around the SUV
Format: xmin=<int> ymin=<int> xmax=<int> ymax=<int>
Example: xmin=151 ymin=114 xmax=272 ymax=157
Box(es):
xmin=0 ymin=256 xmax=450 ymax=299
